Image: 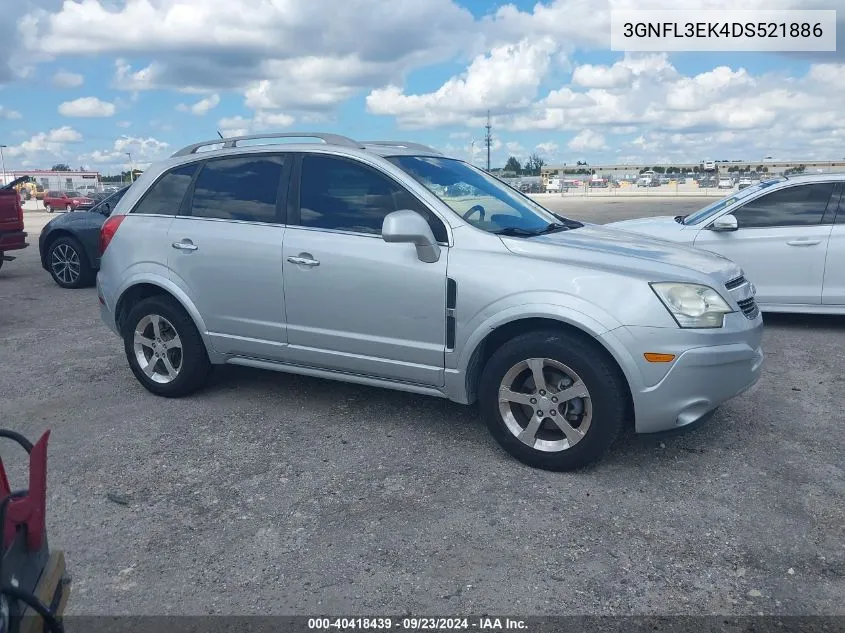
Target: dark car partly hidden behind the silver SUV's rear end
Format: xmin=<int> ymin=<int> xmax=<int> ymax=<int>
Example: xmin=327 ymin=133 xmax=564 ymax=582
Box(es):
xmin=38 ymin=187 xmax=129 ymax=288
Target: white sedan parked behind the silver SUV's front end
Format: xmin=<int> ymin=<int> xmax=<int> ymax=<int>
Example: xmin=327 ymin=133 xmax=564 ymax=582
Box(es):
xmin=608 ymin=174 xmax=845 ymax=314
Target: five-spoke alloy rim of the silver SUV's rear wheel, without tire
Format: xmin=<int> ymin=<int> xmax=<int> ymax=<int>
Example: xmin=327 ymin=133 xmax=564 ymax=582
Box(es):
xmin=133 ymin=314 xmax=182 ymax=385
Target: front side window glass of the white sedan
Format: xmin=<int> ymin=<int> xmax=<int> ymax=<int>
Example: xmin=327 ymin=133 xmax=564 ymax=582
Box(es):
xmin=734 ymin=182 xmax=833 ymax=228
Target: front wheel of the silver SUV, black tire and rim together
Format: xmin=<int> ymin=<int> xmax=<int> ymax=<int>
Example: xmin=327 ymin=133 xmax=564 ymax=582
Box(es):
xmin=478 ymin=330 xmax=627 ymax=471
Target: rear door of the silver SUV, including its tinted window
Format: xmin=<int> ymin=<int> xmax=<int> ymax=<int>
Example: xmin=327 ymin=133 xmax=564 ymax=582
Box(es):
xmin=168 ymin=153 xmax=290 ymax=360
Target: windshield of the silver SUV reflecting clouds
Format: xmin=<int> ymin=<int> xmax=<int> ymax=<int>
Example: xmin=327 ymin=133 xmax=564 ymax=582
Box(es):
xmin=388 ymin=156 xmax=581 ymax=236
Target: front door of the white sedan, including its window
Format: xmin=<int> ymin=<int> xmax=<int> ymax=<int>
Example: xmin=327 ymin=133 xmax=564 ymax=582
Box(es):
xmin=695 ymin=183 xmax=833 ymax=305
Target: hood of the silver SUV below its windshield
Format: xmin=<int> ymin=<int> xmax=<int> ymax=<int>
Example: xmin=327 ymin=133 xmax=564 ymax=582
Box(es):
xmin=502 ymin=223 xmax=741 ymax=283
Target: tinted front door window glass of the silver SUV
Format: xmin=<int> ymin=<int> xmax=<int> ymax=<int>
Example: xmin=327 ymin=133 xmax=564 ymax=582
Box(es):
xmin=299 ymin=154 xmax=448 ymax=242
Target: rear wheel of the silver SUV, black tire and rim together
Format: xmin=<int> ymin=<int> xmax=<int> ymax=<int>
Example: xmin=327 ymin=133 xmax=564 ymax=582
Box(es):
xmin=123 ymin=296 xmax=211 ymax=398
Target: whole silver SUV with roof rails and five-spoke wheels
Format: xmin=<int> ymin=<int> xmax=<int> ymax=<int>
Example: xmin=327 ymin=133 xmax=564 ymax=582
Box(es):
xmin=97 ymin=133 xmax=763 ymax=470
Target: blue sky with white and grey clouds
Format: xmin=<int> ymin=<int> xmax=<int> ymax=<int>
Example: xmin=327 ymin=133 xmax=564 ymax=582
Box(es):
xmin=0 ymin=0 xmax=845 ymax=174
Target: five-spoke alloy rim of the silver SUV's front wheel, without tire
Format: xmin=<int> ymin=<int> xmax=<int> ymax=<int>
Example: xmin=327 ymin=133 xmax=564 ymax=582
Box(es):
xmin=499 ymin=358 xmax=593 ymax=452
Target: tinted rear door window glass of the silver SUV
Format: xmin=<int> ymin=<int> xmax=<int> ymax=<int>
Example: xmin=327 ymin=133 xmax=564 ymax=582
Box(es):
xmin=190 ymin=154 xmax=285 ymax=222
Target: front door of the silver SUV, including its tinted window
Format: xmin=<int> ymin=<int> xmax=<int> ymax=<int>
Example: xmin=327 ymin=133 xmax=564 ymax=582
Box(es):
xmin=282 ymin=154 xmax=448 ymax=386
